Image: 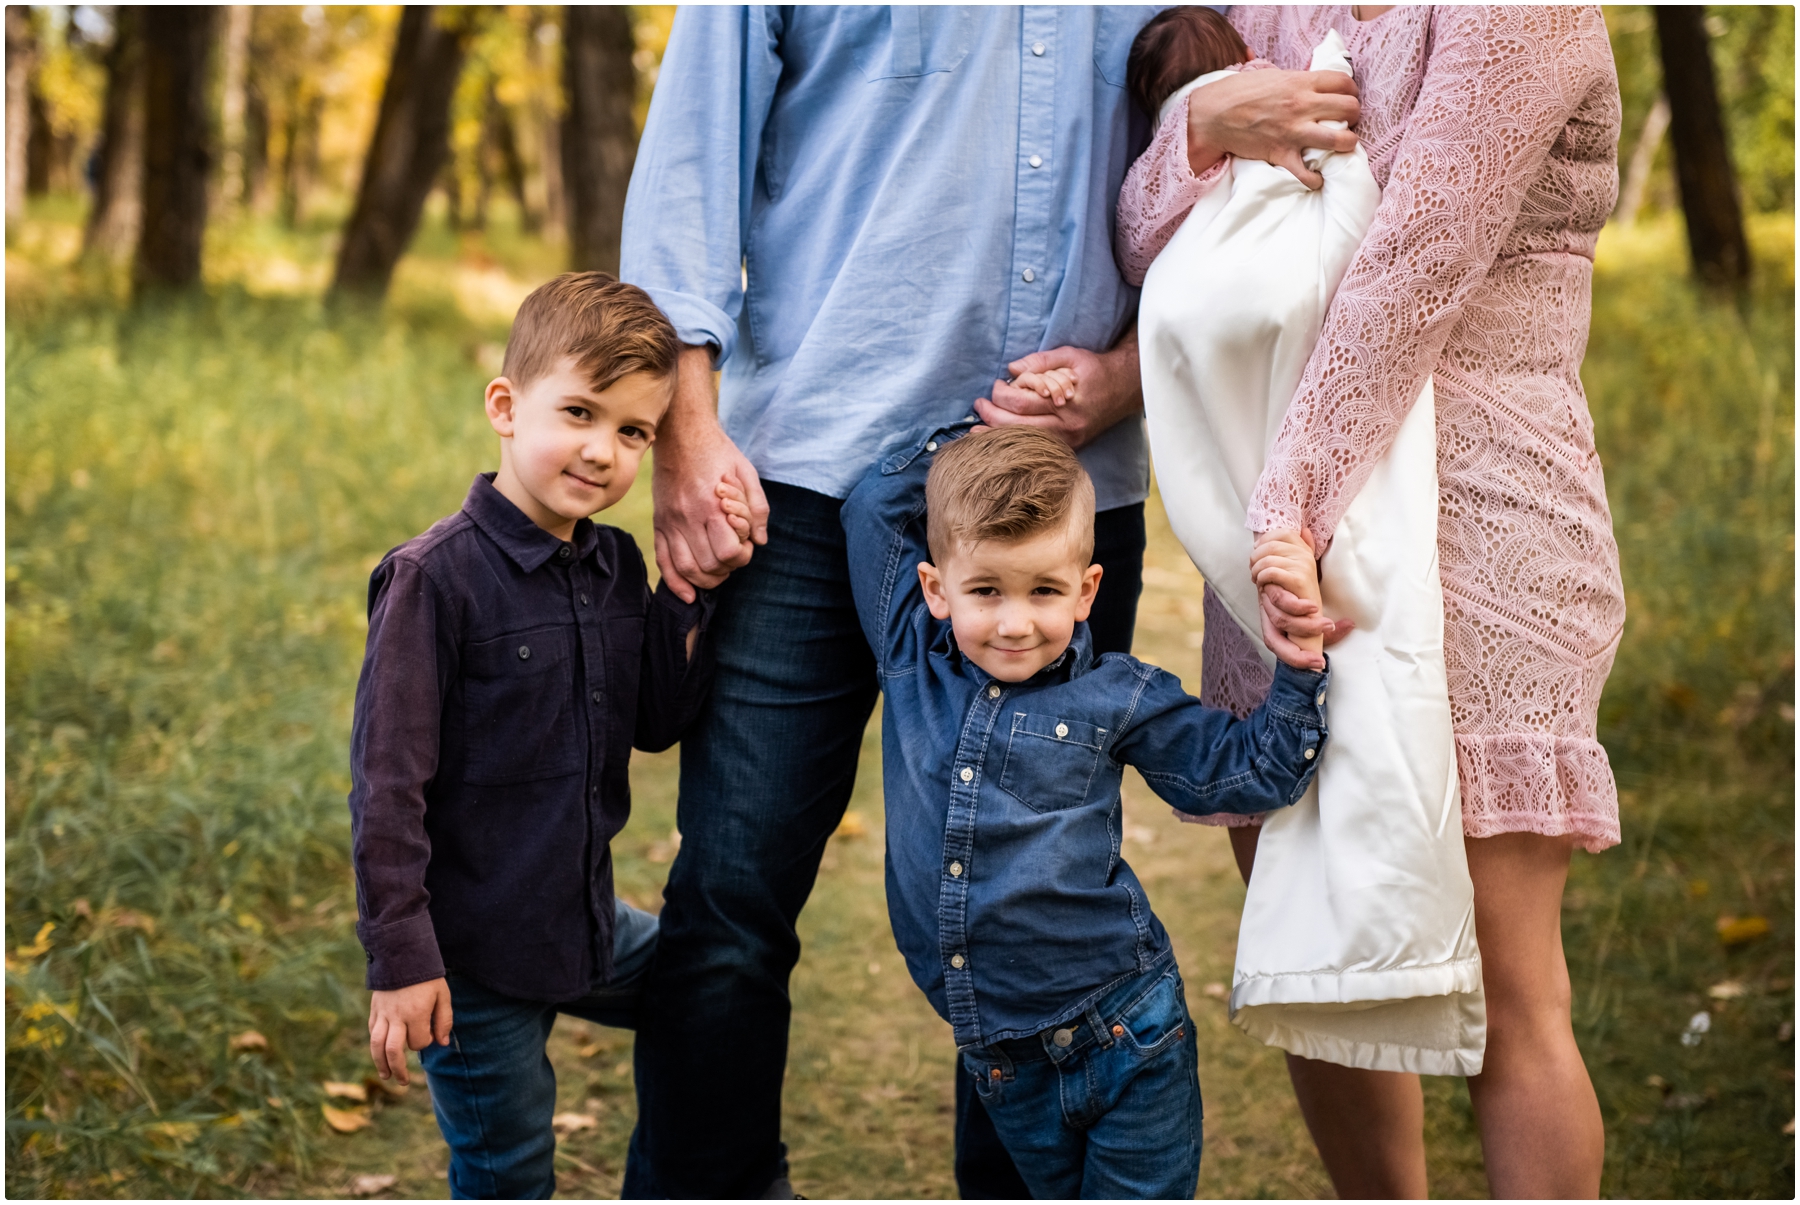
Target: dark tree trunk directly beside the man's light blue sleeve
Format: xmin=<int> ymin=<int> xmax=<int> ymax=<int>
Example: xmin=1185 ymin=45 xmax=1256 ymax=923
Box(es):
xmin=562 ymin=4 xmax=637 ymax=272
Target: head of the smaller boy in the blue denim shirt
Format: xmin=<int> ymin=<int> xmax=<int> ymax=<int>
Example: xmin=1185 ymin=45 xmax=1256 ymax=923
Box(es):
xmin=918 ymin=427 xmax=1100 ymax=683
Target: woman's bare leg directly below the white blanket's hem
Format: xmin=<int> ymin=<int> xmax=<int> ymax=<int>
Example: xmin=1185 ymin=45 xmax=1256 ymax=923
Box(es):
xmin=1229 ymin=829 xmax=1425 ymax=1200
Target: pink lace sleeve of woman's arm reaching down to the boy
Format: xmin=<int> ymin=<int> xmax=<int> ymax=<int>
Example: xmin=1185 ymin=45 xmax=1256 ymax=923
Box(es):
xmin=1246 ymin=5 xmax=1600 ymax=549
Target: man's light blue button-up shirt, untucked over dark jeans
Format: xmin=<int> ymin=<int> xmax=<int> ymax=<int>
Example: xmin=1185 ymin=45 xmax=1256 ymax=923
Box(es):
xmin=621 ymin=5 xmax=1156 ymax=510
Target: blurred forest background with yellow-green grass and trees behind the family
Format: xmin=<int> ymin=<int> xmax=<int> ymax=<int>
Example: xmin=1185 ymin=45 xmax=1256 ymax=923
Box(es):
xmin=5 ymin=5 xmax=1795 ymax=1198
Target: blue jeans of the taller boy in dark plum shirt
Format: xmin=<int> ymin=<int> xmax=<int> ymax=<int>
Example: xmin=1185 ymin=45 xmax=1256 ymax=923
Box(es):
xmin=419 ymin=901 xmax=657 ymax=1200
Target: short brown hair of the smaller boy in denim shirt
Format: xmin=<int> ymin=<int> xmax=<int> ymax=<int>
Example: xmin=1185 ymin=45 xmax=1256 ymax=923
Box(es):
xmin=925 ymin=427 xmax=1094 ymax=567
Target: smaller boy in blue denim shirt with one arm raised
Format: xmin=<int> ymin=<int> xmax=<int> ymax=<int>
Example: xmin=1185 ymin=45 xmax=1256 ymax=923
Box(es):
xmin=842 ymin=421 xmax=1327 ymax=1198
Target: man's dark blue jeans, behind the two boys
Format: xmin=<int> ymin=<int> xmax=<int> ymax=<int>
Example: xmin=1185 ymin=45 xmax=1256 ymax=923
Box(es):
xmin=623 ymin=483 xmax=1145 ymax=1198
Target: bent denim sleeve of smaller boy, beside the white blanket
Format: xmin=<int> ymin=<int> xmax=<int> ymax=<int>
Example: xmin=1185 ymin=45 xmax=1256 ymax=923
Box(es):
xmin=1112 ymin=665 xmax=1330 ymax=816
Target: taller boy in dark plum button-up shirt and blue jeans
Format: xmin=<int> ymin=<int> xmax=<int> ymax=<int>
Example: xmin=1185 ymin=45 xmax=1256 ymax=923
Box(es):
xmin=349 ymin=272 xmax=749 ymax=1198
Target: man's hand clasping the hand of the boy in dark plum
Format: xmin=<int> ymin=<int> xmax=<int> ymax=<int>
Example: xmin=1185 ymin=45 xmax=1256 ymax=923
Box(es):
xmin=650 ymin=348 xmax=769 ymax=602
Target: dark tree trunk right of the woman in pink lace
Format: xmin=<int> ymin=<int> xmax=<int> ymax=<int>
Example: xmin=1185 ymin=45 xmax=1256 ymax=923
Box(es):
xmin=1652 ymin=4 xmax=1750 ymax=285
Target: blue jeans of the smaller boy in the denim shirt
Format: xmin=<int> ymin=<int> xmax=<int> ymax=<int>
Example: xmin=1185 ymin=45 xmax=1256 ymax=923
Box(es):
xmin=963 ymin=958 xmax=1201 ymax=1200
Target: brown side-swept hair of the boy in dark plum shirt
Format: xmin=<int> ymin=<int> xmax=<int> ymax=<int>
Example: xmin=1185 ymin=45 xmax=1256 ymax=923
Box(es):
xmin=500 ymin=272 xmax=680 ymax=393
